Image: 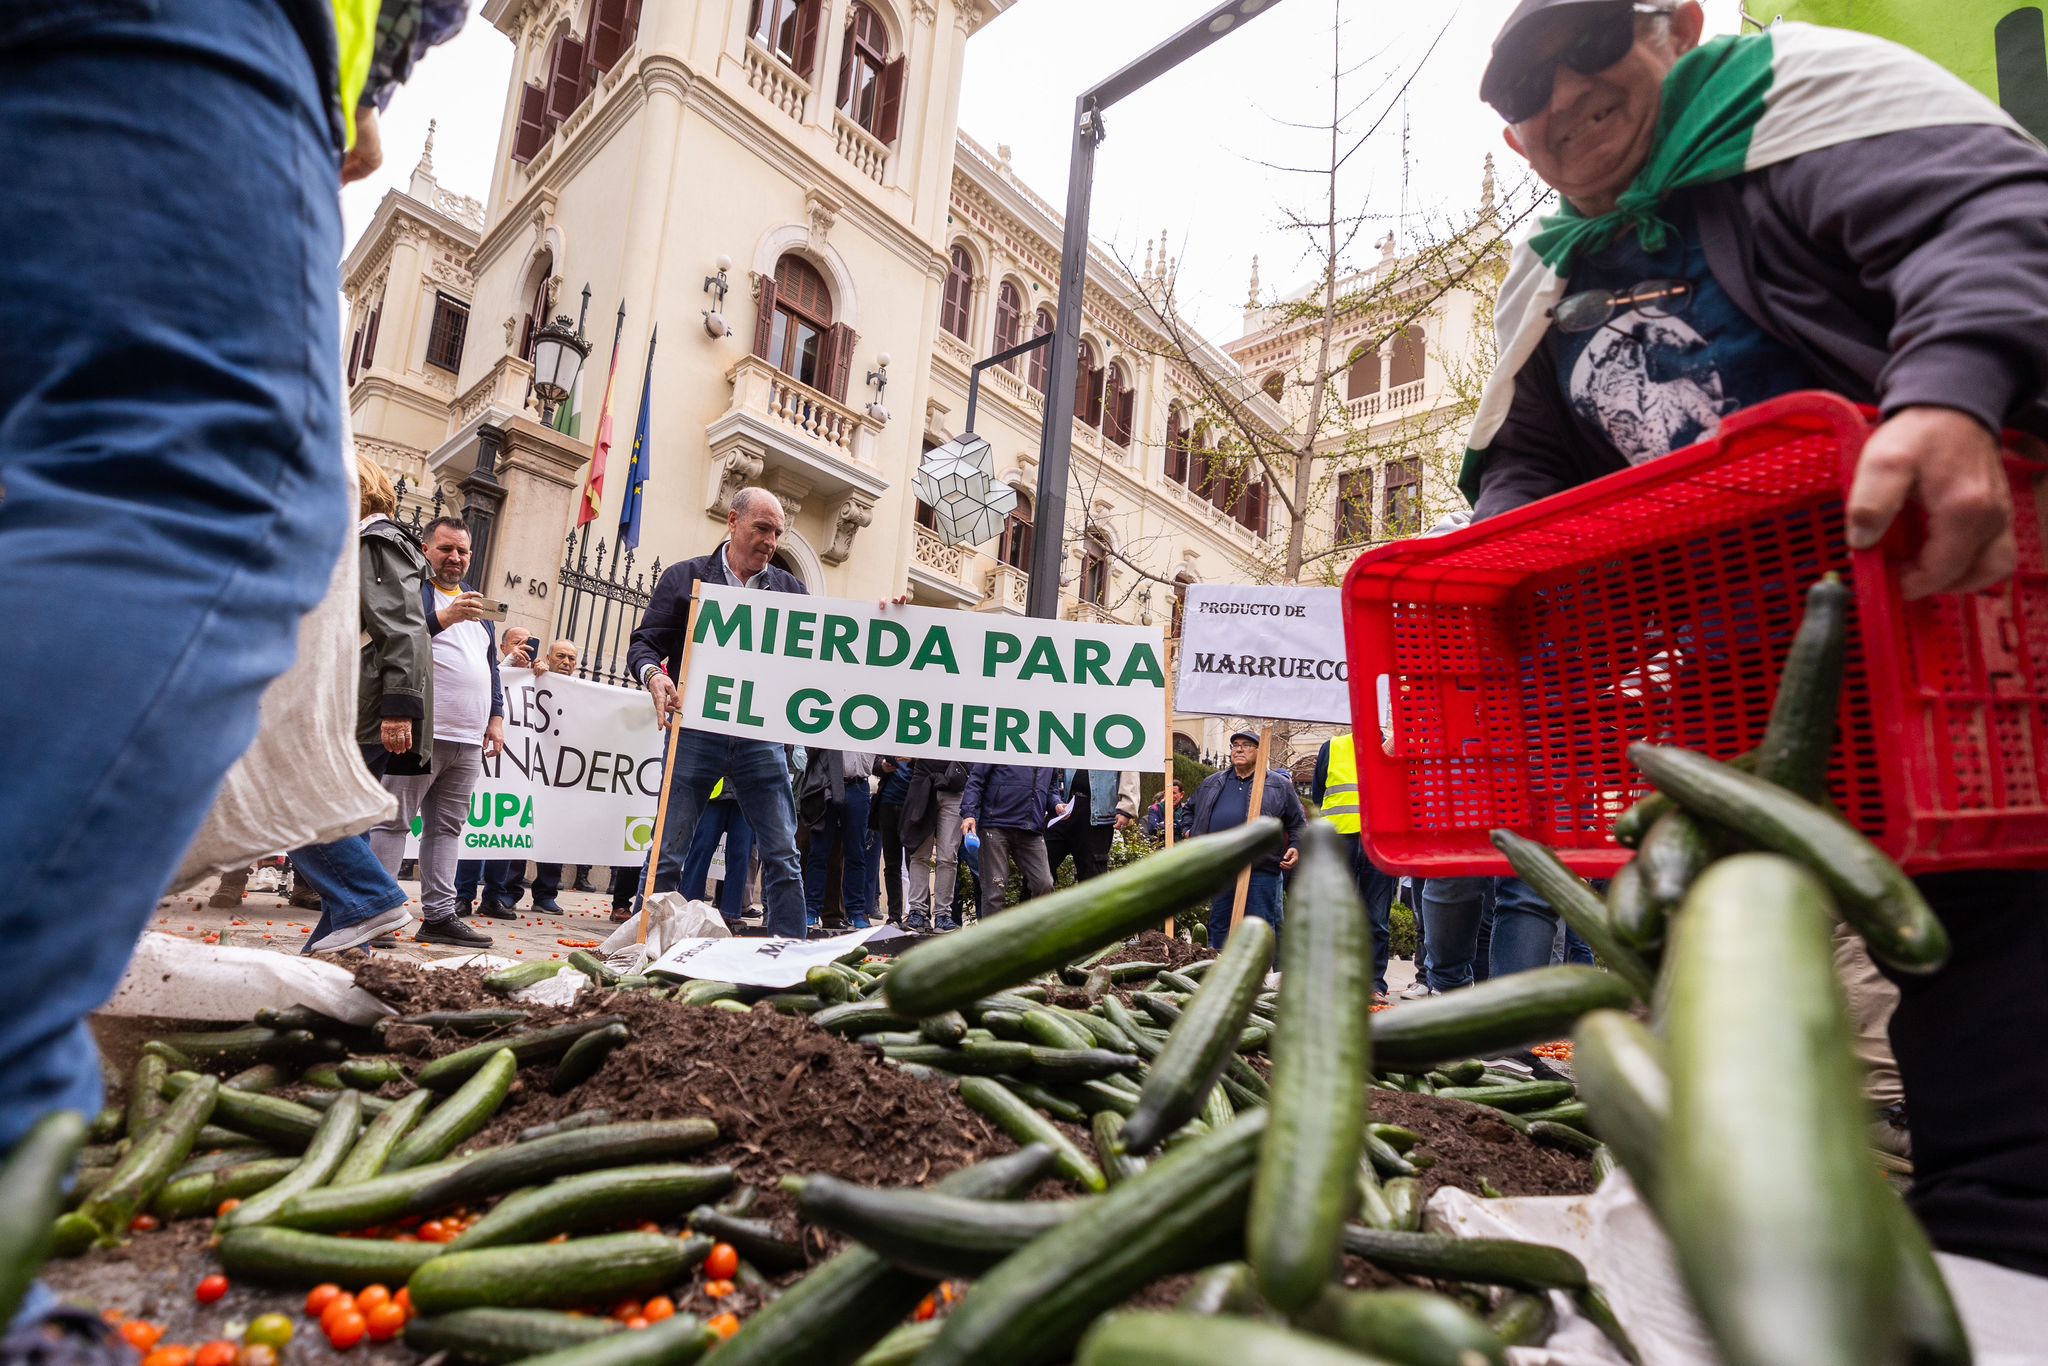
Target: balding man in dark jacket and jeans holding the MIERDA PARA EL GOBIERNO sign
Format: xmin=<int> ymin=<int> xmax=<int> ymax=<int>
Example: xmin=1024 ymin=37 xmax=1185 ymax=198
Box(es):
xmin=627 ymin=487 xmax=805 ymax=940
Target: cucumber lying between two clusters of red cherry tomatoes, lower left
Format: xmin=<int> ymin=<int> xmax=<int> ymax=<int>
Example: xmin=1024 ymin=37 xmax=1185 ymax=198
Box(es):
xmin=407 ymin=1233 xmax=711 ymax=1315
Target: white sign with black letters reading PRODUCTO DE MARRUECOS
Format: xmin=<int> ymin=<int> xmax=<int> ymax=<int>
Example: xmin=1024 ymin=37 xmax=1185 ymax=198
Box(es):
xmin=1174 ymin=584 xmax=1352 ymax=725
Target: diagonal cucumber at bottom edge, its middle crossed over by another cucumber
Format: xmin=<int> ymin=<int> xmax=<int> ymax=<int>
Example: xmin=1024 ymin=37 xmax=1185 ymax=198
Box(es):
xmin=719 ymin=1145 xmax=1053 ymax=1366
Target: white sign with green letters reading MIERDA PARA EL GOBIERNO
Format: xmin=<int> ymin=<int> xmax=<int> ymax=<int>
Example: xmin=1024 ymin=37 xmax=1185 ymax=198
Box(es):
xmin=682 ymin=584 xmax=1165 ymax=768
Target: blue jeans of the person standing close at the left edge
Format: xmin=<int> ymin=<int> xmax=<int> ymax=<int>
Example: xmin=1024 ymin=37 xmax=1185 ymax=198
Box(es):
xmin=0 ymin=0 xmax=352 ymax=1153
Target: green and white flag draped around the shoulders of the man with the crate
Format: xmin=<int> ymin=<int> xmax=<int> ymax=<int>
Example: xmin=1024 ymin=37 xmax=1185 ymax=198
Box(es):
xmin=1458 ymin=25 xmax=2019 ymax=502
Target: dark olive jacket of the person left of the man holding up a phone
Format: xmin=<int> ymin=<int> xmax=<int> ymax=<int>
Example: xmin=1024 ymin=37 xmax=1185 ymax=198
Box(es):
xmin=356 ymin=518 xmax=434 ymax=772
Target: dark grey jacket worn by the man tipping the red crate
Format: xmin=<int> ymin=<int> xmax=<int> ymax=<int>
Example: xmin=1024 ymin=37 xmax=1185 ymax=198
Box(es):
xmin=1473 ymin=125 xmax=2048 ymax=520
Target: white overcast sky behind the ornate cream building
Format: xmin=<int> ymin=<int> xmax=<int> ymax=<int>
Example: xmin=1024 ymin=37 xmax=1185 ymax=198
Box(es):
xmin=342 ymin=0 xmax=1735 ymax=342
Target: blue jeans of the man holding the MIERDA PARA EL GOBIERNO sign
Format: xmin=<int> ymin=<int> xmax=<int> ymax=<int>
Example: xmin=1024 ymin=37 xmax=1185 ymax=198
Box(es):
xmin=653 ymin=731 xmax=805 ymax=940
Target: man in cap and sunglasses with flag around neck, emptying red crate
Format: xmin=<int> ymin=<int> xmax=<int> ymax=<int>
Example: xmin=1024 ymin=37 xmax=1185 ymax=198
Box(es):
xmin=1466 ymin=0 xmax=2048 ymax=1274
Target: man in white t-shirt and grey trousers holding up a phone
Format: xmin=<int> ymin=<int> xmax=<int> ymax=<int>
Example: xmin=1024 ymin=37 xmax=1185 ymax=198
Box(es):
xmin=371 ymin=516 xmax=506 ymax=948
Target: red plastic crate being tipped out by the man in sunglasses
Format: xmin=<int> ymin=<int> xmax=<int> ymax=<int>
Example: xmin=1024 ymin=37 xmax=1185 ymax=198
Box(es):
xmin=1343 ymin=393 xmax=2048 ymax=877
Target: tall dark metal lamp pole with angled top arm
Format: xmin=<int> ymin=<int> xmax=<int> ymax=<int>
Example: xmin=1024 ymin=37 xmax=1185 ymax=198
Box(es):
xmin=1024 ymin=0 xmax=1280 ymax=618
